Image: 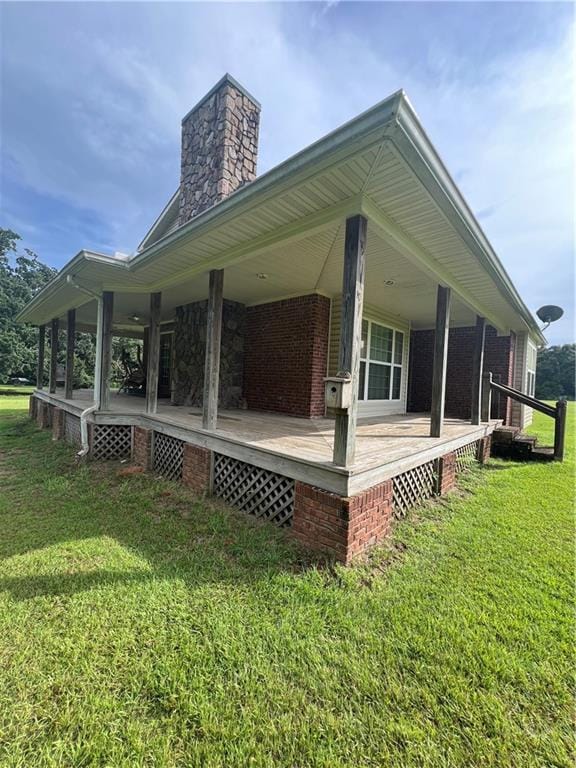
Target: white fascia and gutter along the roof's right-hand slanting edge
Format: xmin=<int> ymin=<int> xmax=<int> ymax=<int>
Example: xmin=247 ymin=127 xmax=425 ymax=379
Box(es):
xmin=391 ymin=95 xmax=545 ymax=342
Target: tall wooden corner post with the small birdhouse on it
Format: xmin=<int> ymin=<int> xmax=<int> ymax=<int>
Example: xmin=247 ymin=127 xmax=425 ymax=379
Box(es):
xmin=333 ymin=216 xmax=368 ymax=467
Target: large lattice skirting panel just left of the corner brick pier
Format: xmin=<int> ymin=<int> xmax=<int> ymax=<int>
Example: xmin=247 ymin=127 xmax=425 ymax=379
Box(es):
xmin=214 ymin=453 xmax=294 ymax=525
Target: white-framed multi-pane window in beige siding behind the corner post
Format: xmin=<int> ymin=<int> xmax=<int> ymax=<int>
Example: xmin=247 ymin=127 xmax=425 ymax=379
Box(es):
xmin=358 ymin=320 xmax=404 ymax=400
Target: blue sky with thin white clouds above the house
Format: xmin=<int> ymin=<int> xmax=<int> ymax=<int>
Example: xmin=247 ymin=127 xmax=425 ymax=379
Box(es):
xmin=0 ymin=2 xmax=575 ymax=343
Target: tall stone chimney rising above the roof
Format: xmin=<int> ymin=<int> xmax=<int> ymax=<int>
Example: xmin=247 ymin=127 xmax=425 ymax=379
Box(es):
xmin=178 ymin=74 xmax=260 ymax=224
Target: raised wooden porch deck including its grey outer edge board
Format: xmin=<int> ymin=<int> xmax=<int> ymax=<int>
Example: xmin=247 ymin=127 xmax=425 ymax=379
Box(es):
xmin=36 ymin=389 xmax=500 ymax=495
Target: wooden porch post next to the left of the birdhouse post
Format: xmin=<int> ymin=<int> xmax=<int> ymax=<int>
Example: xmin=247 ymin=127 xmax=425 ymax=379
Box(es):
xmin=202 ymin=269 xmax=224 ymax=430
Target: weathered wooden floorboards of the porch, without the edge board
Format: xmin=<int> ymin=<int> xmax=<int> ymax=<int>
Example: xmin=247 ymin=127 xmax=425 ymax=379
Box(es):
xmin=42 ymin=390 xmax=498 ymax=472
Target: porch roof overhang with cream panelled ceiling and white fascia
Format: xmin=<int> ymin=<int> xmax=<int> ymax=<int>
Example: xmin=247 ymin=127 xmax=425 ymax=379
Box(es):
xmin=18 ymin=91 xmax=545 ymax=343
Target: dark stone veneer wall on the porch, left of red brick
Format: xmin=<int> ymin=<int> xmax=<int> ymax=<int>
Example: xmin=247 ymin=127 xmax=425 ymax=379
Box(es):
xmin=172 ymin=299 xmax=246 ymax=408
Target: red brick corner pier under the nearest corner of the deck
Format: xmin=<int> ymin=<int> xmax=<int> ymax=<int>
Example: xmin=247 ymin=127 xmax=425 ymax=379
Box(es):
xmin=292 ymin=480 xmax=392 ymax=564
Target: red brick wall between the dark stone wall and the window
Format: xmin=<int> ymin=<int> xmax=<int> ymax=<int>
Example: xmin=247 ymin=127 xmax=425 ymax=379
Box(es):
xmin=244 ymin=294 xmax=330 ymax=418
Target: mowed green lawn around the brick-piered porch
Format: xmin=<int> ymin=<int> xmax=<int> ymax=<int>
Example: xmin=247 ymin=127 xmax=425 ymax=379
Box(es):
xmin=0 ymin=397 xmax=575 ymax=768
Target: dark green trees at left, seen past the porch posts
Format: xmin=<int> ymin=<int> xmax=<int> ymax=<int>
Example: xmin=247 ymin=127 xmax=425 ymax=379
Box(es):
xmin=0 ymin=228 xmax=141 ymax=388
